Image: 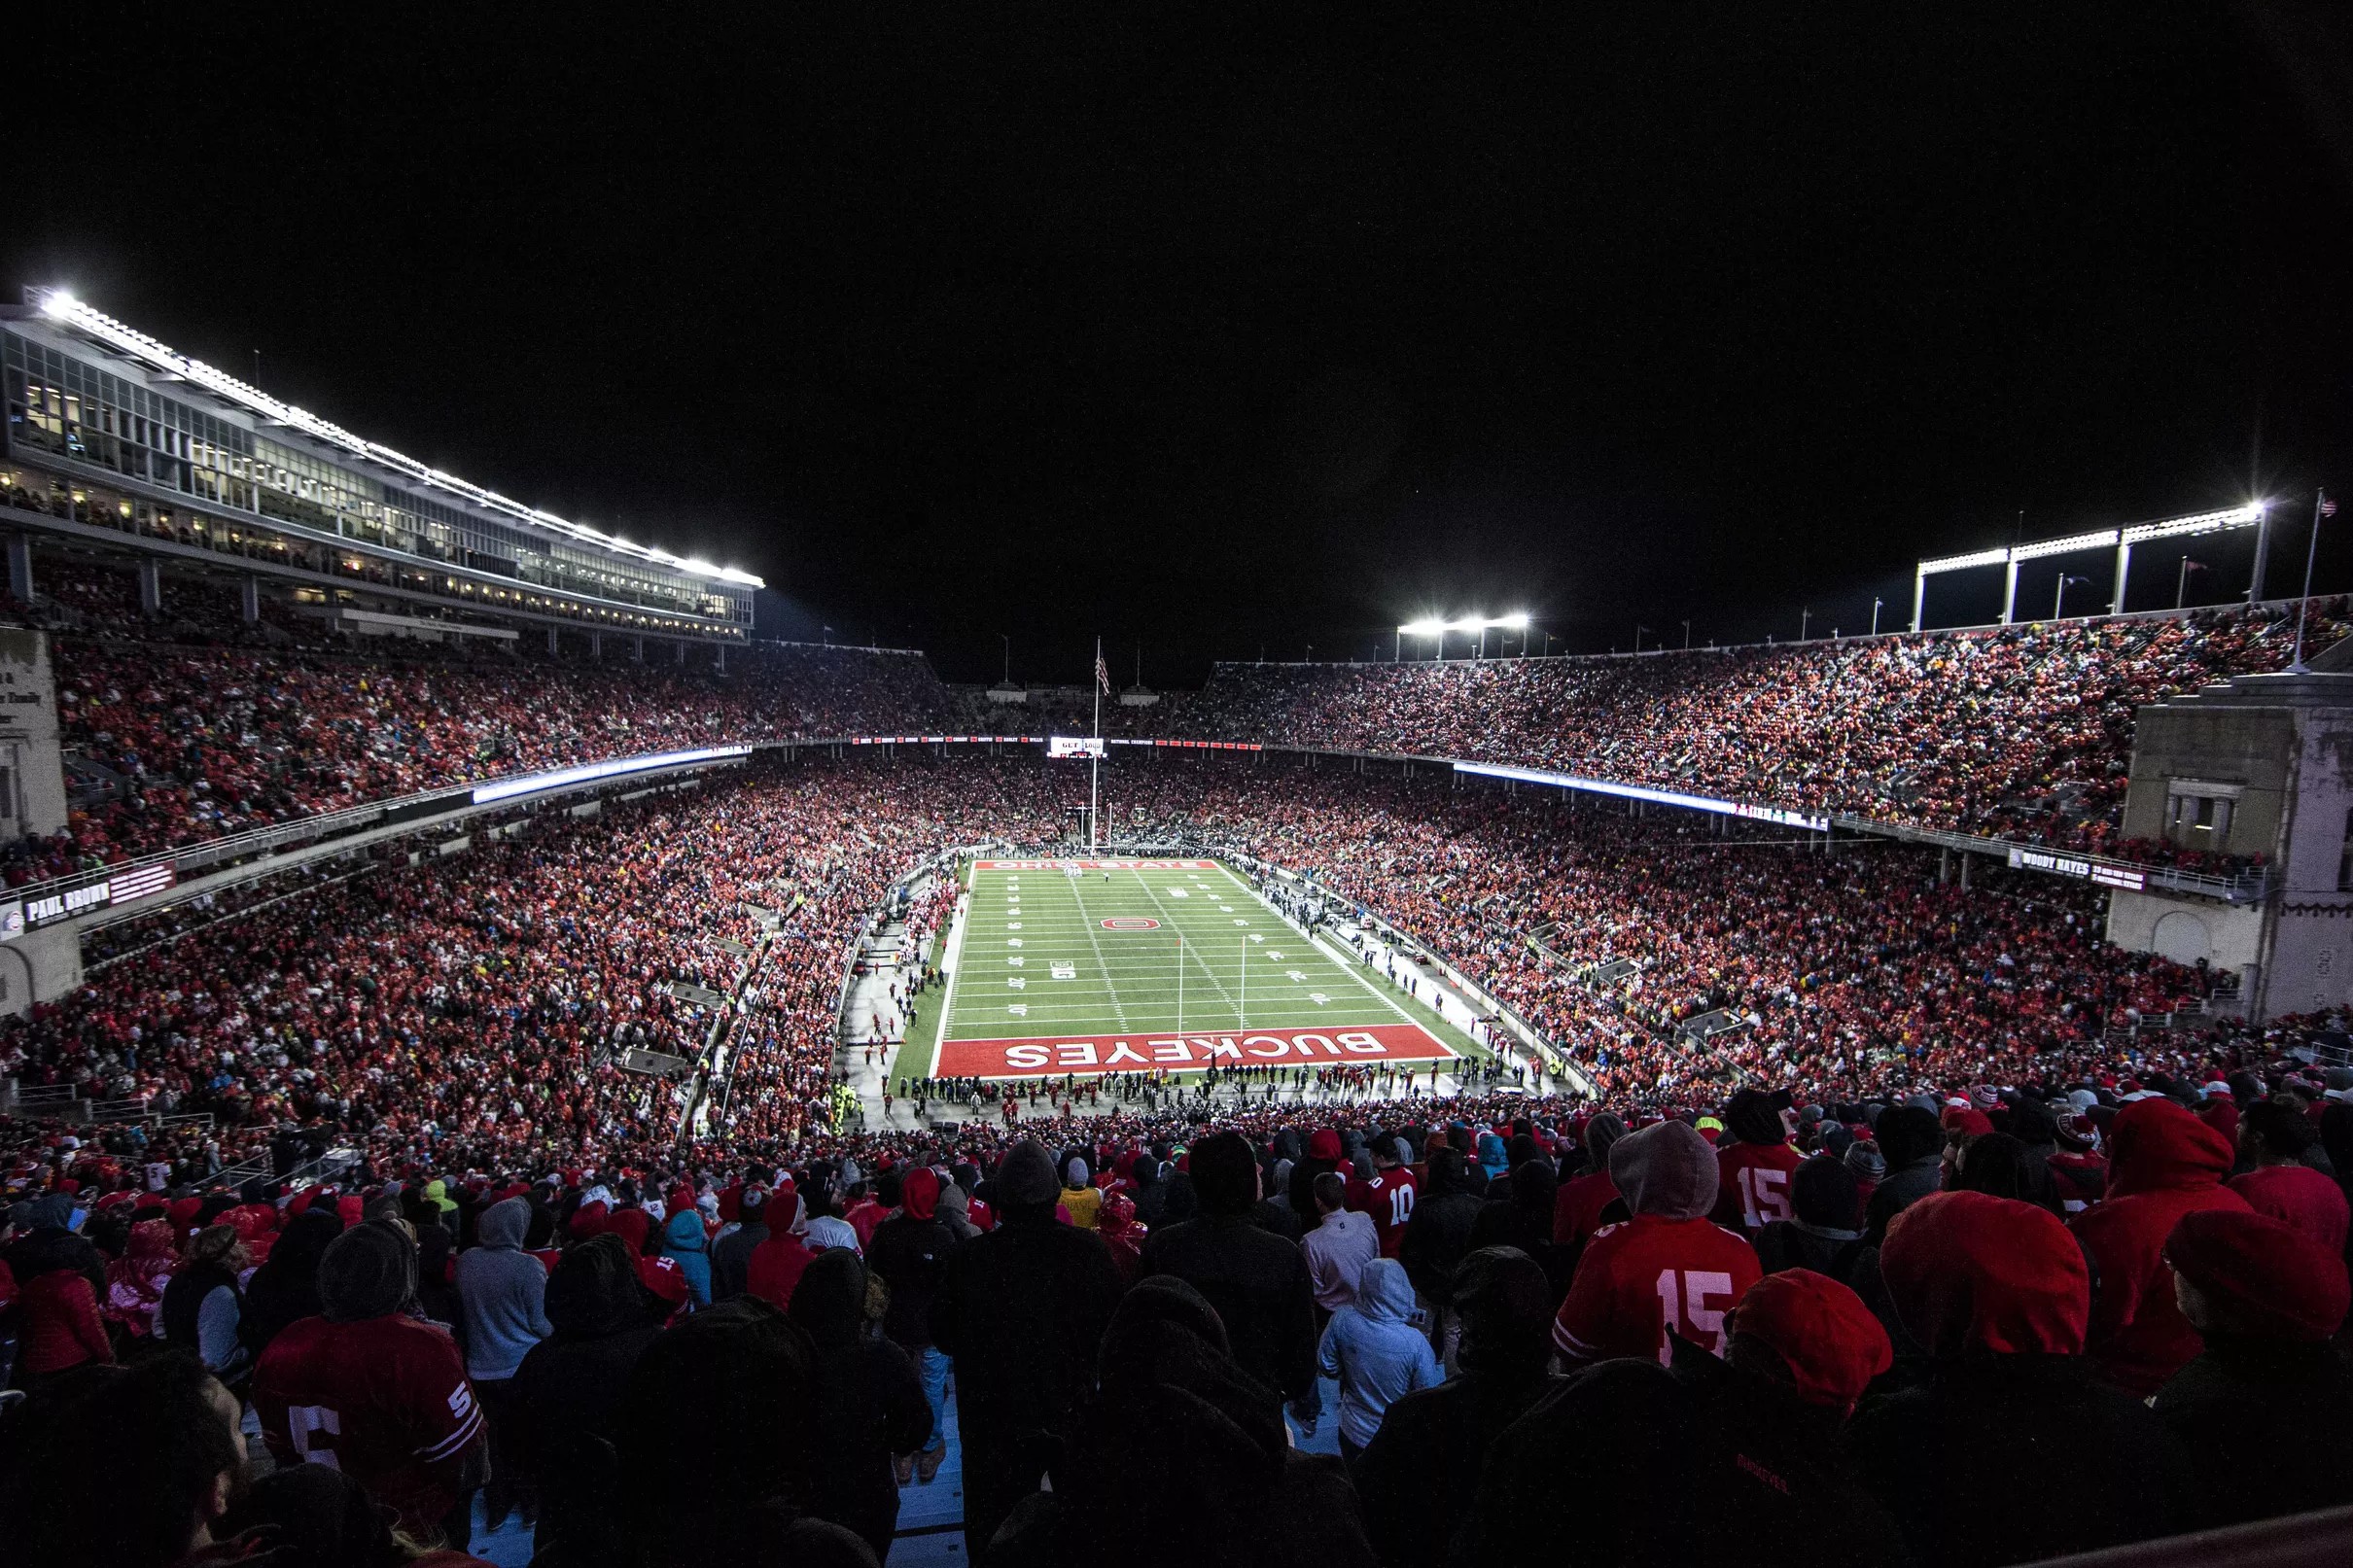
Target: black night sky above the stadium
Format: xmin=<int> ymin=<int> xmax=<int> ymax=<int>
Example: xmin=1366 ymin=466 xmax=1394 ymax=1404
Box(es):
xmin=0 ymin=0 xmax=2353 ymax=684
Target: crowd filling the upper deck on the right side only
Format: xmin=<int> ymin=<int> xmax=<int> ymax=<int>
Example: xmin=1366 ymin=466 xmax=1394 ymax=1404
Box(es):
xmin=1183 ymin=600 xmax=2348 ymax=851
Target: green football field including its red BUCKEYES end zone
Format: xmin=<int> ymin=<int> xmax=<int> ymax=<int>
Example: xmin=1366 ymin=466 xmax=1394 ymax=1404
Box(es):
xmin=922 ymin=858 xmax=1468 ymax=1079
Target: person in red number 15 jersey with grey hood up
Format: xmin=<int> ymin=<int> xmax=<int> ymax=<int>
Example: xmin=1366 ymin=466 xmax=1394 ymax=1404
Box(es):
xmin=1553 ymin=1122 xmax=1765 ymax=1366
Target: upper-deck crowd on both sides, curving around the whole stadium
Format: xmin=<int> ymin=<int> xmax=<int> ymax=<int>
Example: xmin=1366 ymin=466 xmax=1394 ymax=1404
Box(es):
xmin=14 ymin=554 xmax=2348 ymax=882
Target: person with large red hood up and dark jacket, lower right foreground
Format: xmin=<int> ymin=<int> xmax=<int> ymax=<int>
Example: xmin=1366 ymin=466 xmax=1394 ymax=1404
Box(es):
xmin=1847 ymin=1189 xmax=2212 ymax=1568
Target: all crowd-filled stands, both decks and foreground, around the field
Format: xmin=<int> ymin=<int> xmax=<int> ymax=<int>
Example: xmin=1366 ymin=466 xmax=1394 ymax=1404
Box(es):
xmin=0 ymin=574 xmax=2353 ymax=1566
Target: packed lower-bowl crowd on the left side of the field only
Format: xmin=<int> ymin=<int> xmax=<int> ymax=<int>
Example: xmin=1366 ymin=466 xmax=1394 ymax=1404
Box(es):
xmin=0 ymin=759 xmax=1077 ymax=1175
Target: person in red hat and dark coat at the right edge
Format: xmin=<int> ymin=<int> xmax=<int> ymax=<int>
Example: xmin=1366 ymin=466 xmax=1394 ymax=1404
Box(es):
xmin=2148 ymin=1212 xmax=2353 ymax=1528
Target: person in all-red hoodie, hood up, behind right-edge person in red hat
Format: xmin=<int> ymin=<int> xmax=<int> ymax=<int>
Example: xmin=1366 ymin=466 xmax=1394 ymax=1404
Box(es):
xmin=2073 ymin=1100 xmax=2247 ymax=1399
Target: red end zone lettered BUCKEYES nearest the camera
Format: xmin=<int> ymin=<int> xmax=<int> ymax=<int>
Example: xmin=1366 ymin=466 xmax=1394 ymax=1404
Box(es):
xmin=936 ymin=1023 xmax=1457 ymax=1079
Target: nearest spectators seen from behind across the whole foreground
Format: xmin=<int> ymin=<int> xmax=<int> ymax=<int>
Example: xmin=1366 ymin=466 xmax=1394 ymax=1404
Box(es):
xmin=0 ymin=1049 xmax=2353 ymax=1568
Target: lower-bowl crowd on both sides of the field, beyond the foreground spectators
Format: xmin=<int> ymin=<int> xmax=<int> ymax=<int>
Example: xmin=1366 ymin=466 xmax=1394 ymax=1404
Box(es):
xmin=0 ymin=754 xmax=2259 ymax=1189
